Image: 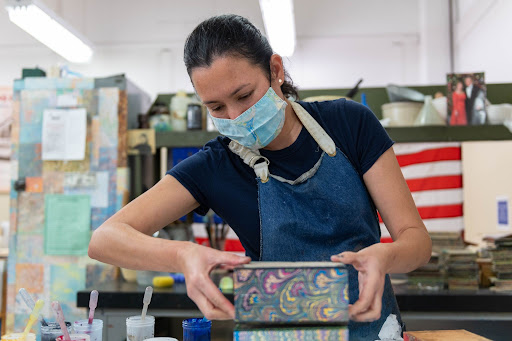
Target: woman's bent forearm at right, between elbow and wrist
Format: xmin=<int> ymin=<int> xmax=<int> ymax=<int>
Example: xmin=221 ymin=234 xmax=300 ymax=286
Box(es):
xmin=368 ymin=228 xmax=432 ymax=273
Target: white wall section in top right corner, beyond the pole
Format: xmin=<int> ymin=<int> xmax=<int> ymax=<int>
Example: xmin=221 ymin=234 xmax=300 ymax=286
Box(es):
xmin=454 ymin=0 xmax=512 ymax=83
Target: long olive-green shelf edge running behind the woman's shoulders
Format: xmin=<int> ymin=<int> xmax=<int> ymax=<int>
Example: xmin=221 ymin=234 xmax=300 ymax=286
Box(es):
xmin=156 ymin=125 xmax=512 ymax=148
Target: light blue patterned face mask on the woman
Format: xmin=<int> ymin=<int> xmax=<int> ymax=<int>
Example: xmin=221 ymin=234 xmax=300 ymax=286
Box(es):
xmin=210 ymin=87 xmax=286 ymax=149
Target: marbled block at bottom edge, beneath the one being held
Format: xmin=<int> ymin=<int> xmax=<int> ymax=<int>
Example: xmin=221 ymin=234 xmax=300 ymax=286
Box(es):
xmin=233 ymin=327 xmax=349 ymax=341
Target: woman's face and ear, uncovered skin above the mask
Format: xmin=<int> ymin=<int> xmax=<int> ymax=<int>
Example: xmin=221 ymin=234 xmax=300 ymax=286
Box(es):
xmin=190 ymin=55 xmax=284 ymax=119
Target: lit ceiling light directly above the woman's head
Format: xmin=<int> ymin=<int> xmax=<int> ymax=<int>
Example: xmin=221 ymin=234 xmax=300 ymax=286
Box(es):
xmin=260 ymin=0 xmax=295 ymax=57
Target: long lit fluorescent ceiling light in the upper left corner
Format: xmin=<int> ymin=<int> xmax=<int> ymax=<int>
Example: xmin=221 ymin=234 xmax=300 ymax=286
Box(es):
xmin=5 ymin=0 xmax=93 ymax=63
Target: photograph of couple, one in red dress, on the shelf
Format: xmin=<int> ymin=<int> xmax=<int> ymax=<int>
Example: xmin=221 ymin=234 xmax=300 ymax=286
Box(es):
xmin=446 ymin=72 xmax=488 ymax=125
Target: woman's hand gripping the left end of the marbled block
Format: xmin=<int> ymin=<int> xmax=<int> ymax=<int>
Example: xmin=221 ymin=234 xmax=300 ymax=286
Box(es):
xmin=180 ymin=243 xmax=251 ymax=320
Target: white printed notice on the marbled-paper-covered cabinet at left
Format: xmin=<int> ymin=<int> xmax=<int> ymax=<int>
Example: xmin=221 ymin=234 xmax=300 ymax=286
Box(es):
xmin=42 ymin=108 xmax=87 ymax=161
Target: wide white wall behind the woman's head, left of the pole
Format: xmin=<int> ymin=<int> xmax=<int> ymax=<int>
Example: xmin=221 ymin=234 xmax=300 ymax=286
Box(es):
xmin=0 ymin=0 xmax=449 ymax=96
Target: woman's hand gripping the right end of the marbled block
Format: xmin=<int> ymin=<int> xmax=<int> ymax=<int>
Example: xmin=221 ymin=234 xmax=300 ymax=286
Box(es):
xmin=331 ymin=244 xmax=387 ymax=322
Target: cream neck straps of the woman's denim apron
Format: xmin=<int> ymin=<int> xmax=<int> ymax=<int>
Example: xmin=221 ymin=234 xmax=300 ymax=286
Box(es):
xmin=229 ymin=101 xmax=336 ymax=183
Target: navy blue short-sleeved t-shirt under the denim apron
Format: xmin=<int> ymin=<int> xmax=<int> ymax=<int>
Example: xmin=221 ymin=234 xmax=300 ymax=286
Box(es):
xmin=167 ymin=99 xmax=393 ymax=260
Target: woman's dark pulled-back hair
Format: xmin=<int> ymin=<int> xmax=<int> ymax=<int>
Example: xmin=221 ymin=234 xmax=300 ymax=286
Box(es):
xmin=183 ymin=14 xmax=299 ymax=99
